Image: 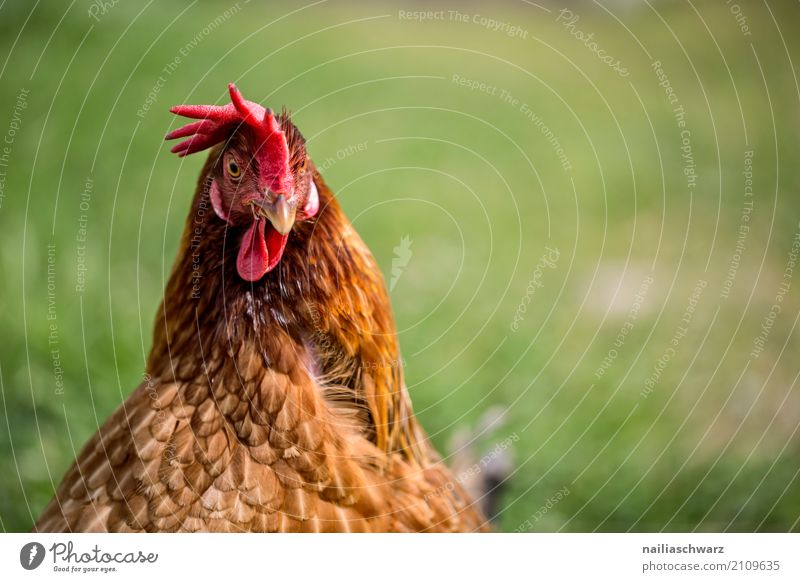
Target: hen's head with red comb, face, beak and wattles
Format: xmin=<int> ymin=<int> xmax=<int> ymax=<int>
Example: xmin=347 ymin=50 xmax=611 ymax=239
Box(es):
xmin=166 ymin=84 xmax=319 ymax=282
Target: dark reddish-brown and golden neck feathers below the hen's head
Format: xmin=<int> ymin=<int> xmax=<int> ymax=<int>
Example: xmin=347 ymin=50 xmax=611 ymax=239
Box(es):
xmin=148 ymin=162 xmax=428 ymax=462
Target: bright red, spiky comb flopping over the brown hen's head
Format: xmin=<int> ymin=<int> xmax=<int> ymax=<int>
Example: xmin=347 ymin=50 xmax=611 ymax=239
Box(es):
xmin=166 ymin=83 xmax=291 ymax=192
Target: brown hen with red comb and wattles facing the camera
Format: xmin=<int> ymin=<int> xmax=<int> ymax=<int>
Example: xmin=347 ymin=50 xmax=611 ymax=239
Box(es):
xmin=34 ymin=85 xmax=488 ymax=532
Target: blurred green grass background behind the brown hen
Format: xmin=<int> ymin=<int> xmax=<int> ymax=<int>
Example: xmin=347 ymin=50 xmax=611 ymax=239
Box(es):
xmin=0 ymin=0 xmax=800 ymax=531
